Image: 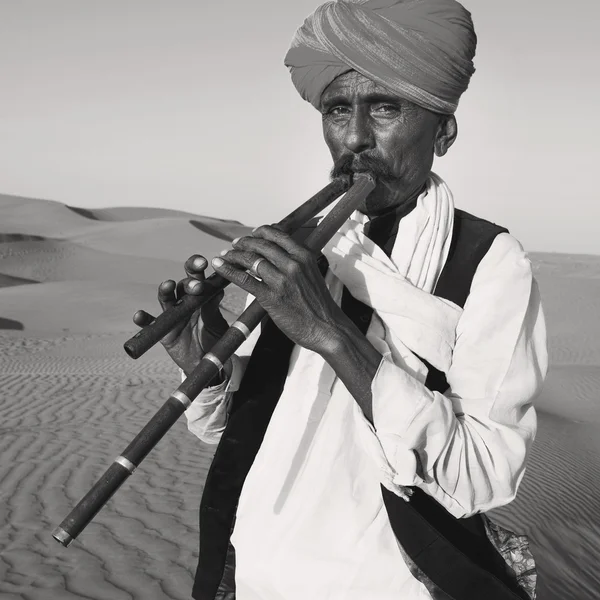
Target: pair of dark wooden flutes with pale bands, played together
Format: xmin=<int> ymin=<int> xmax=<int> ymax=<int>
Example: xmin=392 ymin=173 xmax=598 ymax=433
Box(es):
xmin=52 ymin=173 xmax=375 ymax=547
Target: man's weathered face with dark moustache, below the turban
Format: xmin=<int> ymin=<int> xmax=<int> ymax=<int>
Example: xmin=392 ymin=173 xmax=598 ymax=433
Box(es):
xmin=321 ymin=71 xmax=441 ymax=214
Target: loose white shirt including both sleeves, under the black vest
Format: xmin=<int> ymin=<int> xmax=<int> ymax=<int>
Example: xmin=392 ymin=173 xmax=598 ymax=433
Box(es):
xmin=186 ymin=233 xmax=547 ymax=600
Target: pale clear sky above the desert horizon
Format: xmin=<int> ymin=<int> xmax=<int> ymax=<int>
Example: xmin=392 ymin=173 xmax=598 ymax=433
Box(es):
xmin=0 ymin=0 xmax=600 ymax=254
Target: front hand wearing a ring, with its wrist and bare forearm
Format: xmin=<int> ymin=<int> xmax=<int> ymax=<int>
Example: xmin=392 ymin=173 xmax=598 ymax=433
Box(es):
xmin=212 ymin=226 xmax=382 ymax=423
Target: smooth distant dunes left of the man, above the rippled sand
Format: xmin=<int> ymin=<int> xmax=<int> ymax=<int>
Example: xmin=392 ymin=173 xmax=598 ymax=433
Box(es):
xmin=0 ymin=195 xmax=249 ymax=332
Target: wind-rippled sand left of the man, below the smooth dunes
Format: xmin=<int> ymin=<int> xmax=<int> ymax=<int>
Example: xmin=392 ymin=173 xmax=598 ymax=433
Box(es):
xmin=0 ymin=335 xmax=218 ymax=600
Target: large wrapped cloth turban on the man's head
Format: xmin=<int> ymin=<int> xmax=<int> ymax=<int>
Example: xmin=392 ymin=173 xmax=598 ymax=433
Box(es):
xmin=285 ymin=0 xmax=477 ymax=114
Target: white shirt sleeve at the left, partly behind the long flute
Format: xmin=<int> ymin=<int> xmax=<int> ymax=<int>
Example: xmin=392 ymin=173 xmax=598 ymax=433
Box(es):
xmin=181 ymin=295 xmax=260 ymax=444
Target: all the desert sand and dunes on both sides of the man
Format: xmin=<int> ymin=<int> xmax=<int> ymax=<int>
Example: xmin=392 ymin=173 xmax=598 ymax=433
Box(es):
xmin=0 ymin=195 xmax=600 ymax=600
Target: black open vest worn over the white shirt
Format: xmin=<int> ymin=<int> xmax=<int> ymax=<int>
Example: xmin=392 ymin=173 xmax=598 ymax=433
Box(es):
xmin=192 ymin=209 xmax=528 ymax=600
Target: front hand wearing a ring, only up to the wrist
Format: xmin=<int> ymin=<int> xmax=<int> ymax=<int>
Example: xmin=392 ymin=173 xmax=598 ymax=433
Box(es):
xmin=212 ymin=225 xmax=345 ymax=355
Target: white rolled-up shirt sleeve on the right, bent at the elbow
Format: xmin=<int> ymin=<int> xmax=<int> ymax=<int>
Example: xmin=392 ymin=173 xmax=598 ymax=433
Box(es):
xmin=365 ymin=233 xmax=548 ymax=517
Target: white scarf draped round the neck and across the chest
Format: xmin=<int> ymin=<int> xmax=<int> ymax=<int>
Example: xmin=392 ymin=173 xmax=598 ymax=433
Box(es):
xmin=326 ymin=173 xmax=462 ymax=381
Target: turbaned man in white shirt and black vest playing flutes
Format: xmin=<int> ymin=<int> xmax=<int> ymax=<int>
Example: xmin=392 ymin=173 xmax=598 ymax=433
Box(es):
xmin=141 ymin=0 xmax=547 ymax=600
